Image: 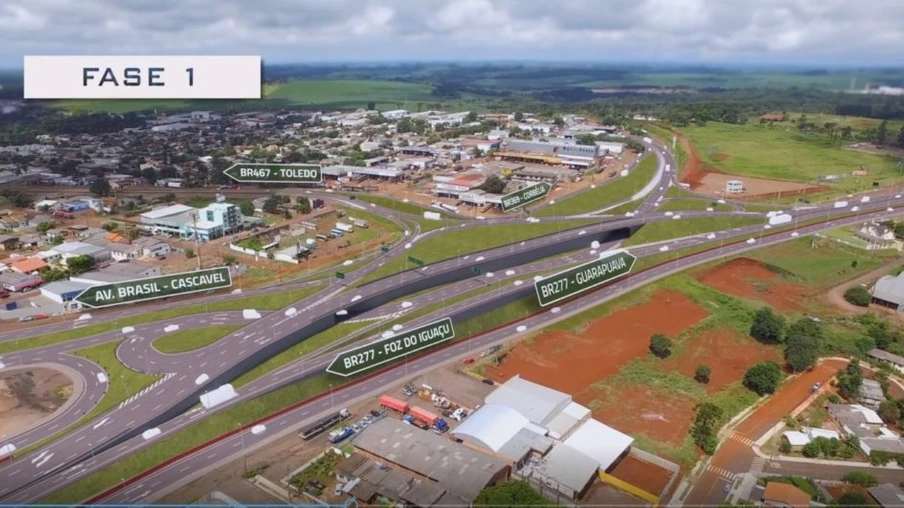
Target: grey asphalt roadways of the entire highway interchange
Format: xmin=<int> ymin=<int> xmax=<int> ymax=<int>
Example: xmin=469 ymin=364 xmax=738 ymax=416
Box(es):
xmin=0 ymin=138 xmax=901 ymax=503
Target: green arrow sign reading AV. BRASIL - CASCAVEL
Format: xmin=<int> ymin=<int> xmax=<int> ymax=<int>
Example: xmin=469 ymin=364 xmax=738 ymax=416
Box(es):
xmin=74 ymin=266 xmax=232 ymax=309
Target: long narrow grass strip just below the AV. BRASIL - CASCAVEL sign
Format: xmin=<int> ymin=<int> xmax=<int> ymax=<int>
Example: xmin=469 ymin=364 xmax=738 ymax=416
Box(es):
xmin=0 ymin=284 xmax=325 ymax=354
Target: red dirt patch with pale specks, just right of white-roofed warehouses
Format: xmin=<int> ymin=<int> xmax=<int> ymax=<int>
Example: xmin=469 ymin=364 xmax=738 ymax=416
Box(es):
xmin=588 ymin=386 xmax=697 ymax=447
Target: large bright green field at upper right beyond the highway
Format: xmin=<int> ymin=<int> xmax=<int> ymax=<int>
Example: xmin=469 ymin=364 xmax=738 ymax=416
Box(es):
xmin=682 ymin=122 xmax=902 ymax=191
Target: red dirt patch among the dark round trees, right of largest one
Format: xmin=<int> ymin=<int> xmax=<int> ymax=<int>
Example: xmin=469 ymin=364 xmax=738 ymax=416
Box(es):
xmin=662 ymin=328 xmax=782 ymax=393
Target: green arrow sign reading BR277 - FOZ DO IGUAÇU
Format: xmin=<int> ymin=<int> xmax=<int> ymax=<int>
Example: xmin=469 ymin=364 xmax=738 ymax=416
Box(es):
xmin=326 ymin=318 xmax=455 ymax=377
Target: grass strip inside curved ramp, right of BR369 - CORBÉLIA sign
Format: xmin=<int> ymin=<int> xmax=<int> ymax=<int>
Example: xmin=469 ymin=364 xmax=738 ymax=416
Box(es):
xmin=531 ymin=155 xmax=656 ymax=217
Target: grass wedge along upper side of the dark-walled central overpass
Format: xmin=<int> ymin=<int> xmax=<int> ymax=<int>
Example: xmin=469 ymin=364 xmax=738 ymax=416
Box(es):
xmin=359 ymin=221 xmax=592 ymax=285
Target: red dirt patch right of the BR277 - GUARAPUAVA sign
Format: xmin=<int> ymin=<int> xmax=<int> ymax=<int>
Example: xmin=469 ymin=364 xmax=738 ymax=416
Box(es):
xmin=696 ymin=258 xmax=809 ymax=311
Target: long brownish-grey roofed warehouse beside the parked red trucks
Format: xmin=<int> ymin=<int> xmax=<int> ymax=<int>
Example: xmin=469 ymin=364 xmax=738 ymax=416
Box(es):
xmin=352 ymin=418 xmax=511 ymax=503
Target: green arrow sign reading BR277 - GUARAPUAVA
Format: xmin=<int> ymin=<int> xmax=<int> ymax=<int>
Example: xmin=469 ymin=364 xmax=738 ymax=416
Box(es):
xmin=534 ymin=251 xmax=637 ymax=307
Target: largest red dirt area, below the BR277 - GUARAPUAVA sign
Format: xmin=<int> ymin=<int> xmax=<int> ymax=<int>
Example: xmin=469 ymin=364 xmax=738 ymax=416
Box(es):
xmin=486 ymin=291 xmax=707 ymax=392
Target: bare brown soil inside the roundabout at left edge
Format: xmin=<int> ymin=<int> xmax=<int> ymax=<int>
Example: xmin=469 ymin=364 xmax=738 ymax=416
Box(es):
xmin=0 ymin=369 xmax=73 ymax=436
